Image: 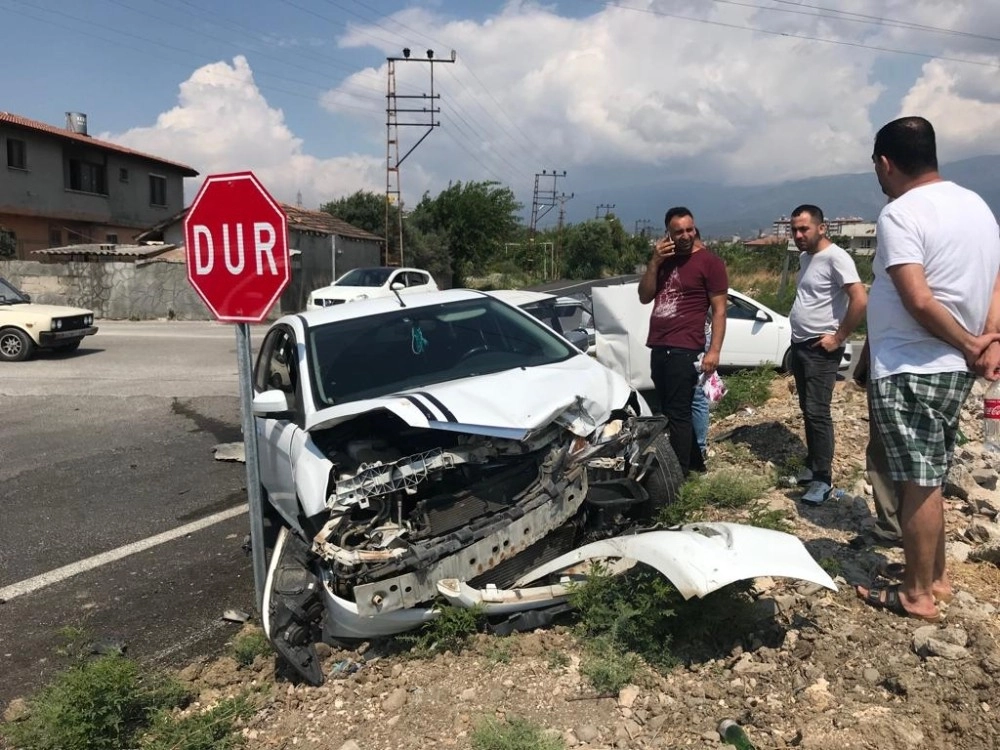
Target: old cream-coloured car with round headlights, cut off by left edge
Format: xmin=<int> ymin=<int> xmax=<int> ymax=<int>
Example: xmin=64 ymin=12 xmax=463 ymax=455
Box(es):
xmin=0 ymin=278 xmax=97 ymax=362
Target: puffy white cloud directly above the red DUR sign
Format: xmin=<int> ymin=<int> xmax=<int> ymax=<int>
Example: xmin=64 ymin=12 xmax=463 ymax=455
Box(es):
xmin=101 ymin=56 xmax=385 ymax=206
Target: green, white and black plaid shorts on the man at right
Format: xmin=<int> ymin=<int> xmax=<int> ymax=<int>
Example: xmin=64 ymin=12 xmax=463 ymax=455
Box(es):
xmin=871 ymin=372 xmax=974 ymax=487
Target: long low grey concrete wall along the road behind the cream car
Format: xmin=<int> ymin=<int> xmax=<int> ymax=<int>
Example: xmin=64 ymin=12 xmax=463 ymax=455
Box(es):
xmin=0 ymin=260 xmax=212 ymax=320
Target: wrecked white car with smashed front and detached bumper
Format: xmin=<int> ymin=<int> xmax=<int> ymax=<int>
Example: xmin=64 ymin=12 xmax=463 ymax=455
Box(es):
xmin=253 ymin=290 xmax=833 ymax=684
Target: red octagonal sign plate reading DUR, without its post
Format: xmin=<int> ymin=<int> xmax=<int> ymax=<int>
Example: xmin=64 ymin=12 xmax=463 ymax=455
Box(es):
xmin=184 ymin=172 xmax=291 ymax=323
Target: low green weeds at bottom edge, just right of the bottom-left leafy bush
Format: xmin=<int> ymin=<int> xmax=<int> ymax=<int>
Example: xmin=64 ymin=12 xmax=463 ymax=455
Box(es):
xmin=139 ymin=696 xmax=254 ymax=750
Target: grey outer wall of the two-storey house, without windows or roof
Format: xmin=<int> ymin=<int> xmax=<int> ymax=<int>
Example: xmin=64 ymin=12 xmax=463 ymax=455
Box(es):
xmin=0 ymin=123 xmax=184 ymax=257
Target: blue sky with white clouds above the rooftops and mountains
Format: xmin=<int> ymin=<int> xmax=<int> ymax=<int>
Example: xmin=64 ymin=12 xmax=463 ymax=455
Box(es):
xmin=0 ymin=0 xmax=1000 ymax=226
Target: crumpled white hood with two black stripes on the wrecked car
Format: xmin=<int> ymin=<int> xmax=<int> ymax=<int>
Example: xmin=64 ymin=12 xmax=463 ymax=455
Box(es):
xmin=304 ymin=354 xmax=631 ymax=439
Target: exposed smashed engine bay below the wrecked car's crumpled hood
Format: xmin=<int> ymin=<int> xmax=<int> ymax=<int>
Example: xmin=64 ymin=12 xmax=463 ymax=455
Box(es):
xmin=312 ymin=410 xmax=679 ymax=614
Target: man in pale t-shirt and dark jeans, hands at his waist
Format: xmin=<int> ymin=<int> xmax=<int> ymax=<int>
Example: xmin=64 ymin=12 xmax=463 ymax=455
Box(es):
xmin=788 ymin=204 xmax=868 ymax=505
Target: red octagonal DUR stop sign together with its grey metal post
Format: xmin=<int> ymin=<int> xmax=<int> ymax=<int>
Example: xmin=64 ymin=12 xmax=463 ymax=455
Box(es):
xmin=184 ymin=172 xmax=291 ymax=612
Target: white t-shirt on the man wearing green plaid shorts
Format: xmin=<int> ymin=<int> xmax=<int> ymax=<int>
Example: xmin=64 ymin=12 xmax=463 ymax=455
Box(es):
xmin=868 ymin=182 xmax=1000 ymax=379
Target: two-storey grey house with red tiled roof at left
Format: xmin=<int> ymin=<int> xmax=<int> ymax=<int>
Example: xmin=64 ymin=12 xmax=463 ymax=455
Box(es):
xmin=0 ymin=111 xmax=198 ymax=260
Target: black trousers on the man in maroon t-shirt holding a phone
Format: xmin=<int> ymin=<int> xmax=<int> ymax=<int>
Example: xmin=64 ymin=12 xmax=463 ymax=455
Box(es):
xmin=649 ymin=346 xmax=704 ymax=476
